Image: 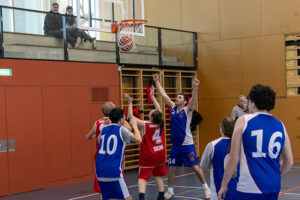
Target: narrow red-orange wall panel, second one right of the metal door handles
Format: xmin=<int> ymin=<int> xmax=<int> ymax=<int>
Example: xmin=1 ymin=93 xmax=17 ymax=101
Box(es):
xmin=44 ymin=87 xmax=72 ymax=181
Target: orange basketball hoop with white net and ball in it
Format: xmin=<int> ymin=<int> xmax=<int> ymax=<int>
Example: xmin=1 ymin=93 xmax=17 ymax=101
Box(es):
xmin=111 ymin=19 xmax=147 ymax=51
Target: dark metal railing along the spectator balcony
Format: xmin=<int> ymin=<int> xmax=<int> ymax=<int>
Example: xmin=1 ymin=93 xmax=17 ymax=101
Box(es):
xmin=0 ymin=5 xmax=198 ymax=69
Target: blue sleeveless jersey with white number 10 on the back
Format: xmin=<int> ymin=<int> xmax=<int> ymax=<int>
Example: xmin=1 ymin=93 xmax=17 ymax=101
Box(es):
xmin=96 ymin=124 xmax=126 ymax=178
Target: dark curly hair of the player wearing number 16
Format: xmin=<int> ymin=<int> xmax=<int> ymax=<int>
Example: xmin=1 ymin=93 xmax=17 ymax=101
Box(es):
xmin=248 ymin=84 xmax=276 ymax=111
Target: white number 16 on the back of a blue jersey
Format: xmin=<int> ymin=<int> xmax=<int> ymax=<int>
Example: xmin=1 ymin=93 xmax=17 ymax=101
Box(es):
xmin=251 ymin=129 xmax=282 ymax=159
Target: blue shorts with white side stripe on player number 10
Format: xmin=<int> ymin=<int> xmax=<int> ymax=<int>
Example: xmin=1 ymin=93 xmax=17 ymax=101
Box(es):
xmin=98 ymin=178 xmax=129 ymax=200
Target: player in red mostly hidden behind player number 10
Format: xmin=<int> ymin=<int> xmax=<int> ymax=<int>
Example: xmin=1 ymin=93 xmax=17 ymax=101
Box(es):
xmin=85 ymin=101 xmax=116 ymax=199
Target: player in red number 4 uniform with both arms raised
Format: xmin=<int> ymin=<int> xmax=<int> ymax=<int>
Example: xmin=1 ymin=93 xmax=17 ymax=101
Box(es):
xmin=125 ymin=86 xmax=167 ymax=200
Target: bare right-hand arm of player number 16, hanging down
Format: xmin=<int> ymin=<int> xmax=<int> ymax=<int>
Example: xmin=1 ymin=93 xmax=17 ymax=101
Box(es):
xmin=280 ymin=130 xmax=294 ymax=175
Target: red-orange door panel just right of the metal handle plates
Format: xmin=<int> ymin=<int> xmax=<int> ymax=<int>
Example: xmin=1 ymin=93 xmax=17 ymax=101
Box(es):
xmin=6 ymin=87 xmax=46 ymax=193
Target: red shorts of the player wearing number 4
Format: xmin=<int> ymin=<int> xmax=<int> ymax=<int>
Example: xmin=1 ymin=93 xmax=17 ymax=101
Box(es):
xmin=138 ymin=164 xmax=168 ymax=180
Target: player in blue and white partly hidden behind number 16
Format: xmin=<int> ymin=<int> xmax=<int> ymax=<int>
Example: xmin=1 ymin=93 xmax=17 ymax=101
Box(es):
xmin=200 ymin=117 xmax=237 ymax=200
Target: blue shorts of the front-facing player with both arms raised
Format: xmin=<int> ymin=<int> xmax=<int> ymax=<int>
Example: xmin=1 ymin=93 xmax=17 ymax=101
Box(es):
xmin=169 ymin=144 xmax=198 ymax=167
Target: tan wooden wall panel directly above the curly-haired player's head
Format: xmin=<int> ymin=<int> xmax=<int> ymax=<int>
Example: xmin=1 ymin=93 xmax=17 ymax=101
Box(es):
xmin=242 ymin=35 xmax=286 ymax=96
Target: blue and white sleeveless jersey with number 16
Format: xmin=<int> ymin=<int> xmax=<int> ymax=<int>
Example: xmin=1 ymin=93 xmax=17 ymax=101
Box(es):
xmin=237 ymin=113 xmax=286 ymax=194
